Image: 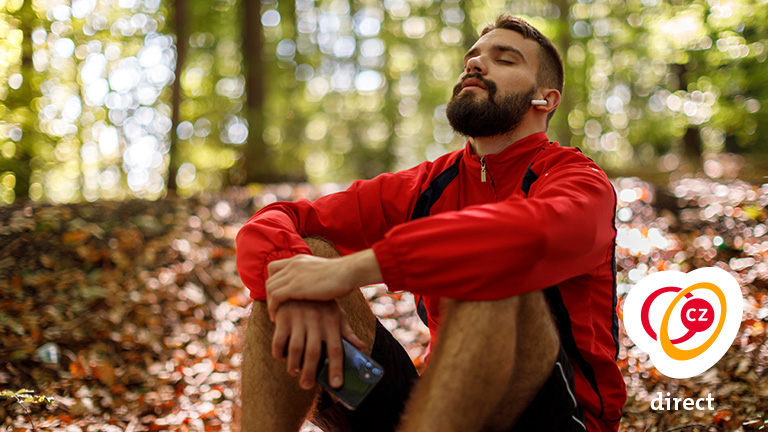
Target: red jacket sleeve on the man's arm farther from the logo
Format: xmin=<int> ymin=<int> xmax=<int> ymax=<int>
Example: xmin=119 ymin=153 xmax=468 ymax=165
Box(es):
xmin=236 ymin=163 xmax=429 ymax=300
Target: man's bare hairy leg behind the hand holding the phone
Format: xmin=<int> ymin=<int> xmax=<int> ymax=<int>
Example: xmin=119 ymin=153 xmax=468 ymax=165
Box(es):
xmin=240 ymin=238 xmax=376 ymax=432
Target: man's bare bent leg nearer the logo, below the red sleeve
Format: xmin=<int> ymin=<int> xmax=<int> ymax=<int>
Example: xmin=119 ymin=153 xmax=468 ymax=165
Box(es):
xmin=399 ymin=292 xmax=559 ymax=431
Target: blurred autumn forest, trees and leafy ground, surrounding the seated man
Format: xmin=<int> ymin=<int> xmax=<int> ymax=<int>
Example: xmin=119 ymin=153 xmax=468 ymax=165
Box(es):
xmin=0 ymin=0 xmax=768 ymax=430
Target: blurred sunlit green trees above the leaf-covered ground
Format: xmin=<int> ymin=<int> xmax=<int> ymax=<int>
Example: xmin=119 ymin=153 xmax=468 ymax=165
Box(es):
xmin=0 ymin=0 xmax=768 ymax=203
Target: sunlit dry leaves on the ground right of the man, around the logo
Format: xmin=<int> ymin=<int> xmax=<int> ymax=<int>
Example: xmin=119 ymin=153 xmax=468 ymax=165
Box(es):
xmin=614 ymin=178 xmax=768 ymax=431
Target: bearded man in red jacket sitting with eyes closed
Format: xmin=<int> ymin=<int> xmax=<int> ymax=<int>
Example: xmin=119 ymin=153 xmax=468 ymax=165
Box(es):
xmin=237 ymin=16 xmax=626 ymax=431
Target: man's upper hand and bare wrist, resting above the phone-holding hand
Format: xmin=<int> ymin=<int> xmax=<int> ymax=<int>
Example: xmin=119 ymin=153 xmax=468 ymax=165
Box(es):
xmin=266 ymin=249 xmax=382 ymax=320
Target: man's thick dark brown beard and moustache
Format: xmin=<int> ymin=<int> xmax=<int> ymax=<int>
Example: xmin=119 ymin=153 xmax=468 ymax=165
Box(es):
xmin=445 ymin=74 xmax=536 ymax=138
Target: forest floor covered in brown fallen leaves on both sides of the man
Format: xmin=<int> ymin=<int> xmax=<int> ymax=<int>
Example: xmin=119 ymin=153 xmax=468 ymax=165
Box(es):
xmin=0 ymin=178 xmax=768 ymax=432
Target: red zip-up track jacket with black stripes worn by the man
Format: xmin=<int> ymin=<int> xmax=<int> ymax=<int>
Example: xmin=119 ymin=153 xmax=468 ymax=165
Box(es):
xmin=237 ymin=133 xmax=626 ymax=431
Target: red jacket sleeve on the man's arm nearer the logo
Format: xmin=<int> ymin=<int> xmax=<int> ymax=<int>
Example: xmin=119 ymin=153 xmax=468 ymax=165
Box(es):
xmin=373 ymin=151 xmax=615 ymax=300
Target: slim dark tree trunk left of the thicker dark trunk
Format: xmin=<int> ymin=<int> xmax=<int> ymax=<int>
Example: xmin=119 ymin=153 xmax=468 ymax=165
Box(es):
xmin=167 ymin=0 xmax=188 ymax=194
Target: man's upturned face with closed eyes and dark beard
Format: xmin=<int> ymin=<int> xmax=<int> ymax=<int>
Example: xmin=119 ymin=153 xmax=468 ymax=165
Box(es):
xmin=446 ymin=29 xmax=539 ymax=137
